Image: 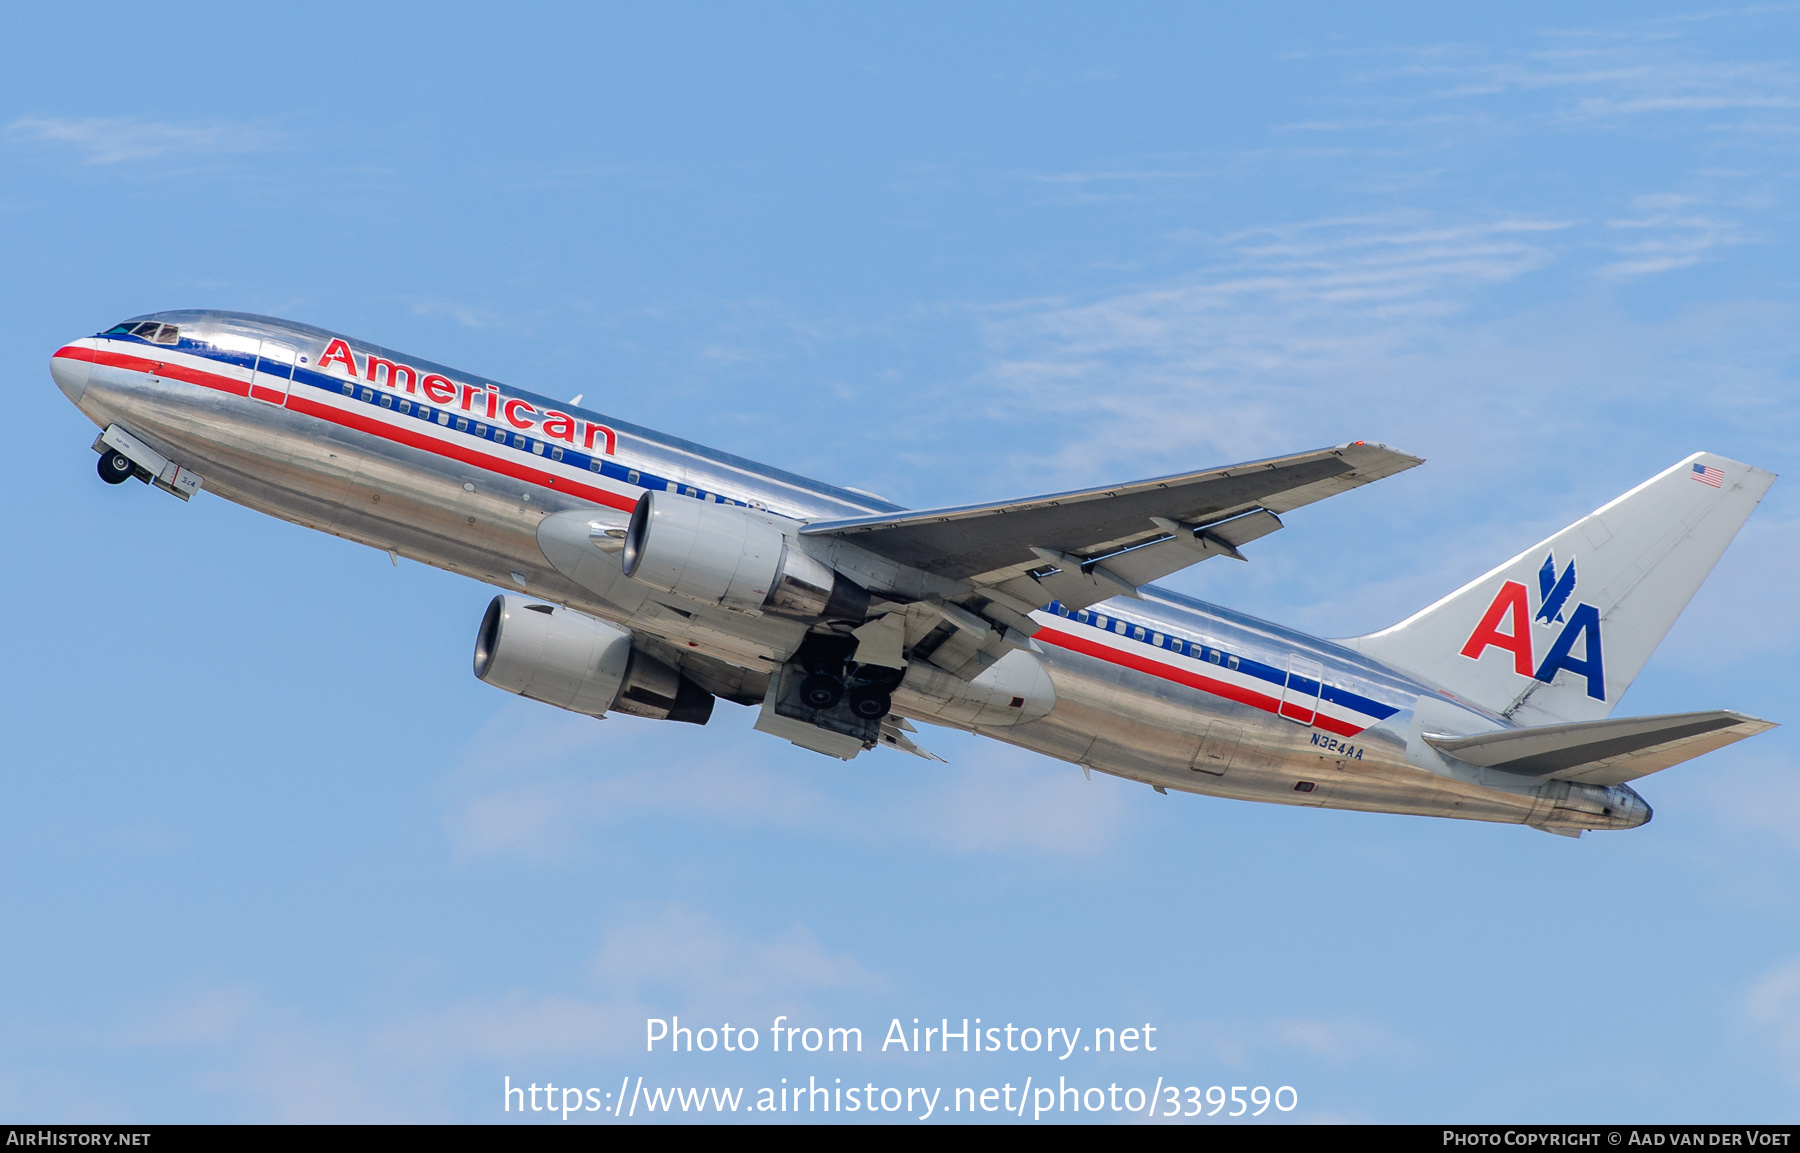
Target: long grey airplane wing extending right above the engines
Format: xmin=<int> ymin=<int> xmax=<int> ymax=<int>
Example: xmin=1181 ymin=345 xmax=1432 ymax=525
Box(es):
xmin=803 ymin=441 xmax=1422 ymax=608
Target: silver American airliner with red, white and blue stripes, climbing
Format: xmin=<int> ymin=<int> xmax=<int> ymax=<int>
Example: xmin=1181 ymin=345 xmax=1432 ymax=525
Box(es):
xmin=50 ymin=311 xmax=1775 ymax=836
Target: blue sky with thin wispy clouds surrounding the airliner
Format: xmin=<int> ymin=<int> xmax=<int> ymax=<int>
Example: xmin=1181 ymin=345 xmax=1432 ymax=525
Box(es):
xmin=0 ymin=4 xmax=1800 ymax=1124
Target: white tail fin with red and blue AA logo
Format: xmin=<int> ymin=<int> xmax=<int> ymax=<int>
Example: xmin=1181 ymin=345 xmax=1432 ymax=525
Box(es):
xmin=1345 ymin=453 xmax=1775 ymax=725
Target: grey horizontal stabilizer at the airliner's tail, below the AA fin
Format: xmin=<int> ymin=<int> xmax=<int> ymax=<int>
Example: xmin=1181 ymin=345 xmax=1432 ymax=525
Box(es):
xmin=1426 ymin=709 xmax=1775 ymax=784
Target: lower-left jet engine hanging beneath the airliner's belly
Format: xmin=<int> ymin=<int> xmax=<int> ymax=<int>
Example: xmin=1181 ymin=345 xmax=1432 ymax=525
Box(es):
xmin=475 ymin=594 xmax=713 ymax=725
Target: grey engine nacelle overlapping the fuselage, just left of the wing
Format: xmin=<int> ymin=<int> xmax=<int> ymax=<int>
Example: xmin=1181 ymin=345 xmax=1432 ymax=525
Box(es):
xmin=619 ymin=493 xmax=869 ymax=622
